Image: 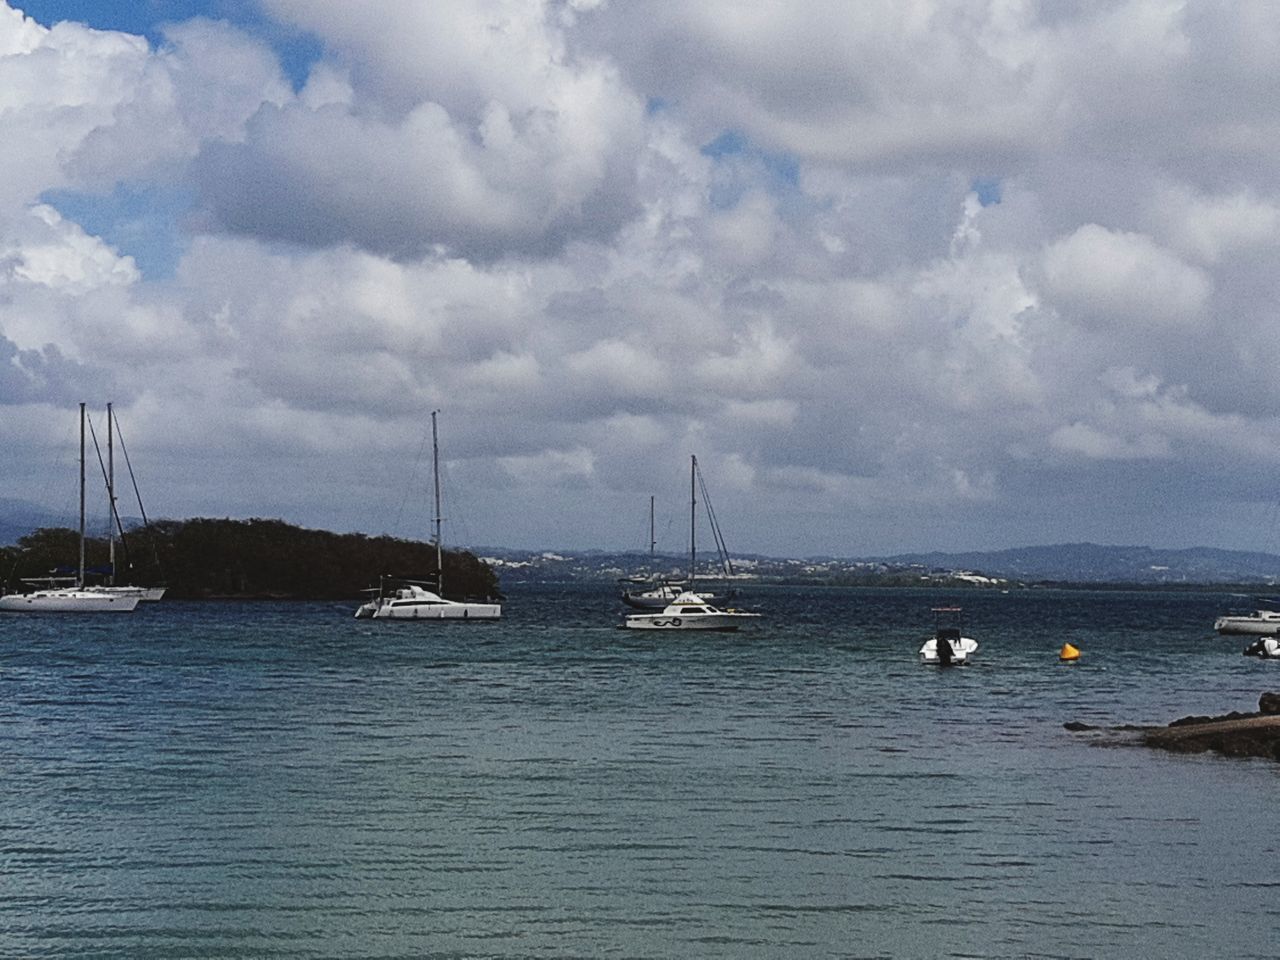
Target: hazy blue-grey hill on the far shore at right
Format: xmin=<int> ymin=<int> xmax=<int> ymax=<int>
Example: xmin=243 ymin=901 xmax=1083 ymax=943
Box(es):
xmin=886 ymin=543 xmax=1280 ymax=584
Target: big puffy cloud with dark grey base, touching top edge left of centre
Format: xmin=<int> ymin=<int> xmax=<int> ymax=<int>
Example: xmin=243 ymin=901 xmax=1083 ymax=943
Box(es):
xmin=186 ymin=3 xmax=644 ymax=260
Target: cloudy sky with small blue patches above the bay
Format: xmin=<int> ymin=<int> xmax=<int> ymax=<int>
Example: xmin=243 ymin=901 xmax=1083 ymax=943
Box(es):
xmin=0 ymin=0 xmax=1280 ymax=556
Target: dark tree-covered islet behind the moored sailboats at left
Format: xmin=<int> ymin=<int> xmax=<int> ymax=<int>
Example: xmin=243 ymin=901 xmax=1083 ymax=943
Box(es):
xmin=0 ymin=518 xmax=502 ymax=600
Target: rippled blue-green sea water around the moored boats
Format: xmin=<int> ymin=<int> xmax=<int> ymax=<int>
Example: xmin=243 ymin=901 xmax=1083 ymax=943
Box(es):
xmin=0 ymin=585 xmax=1280 ymax=959
